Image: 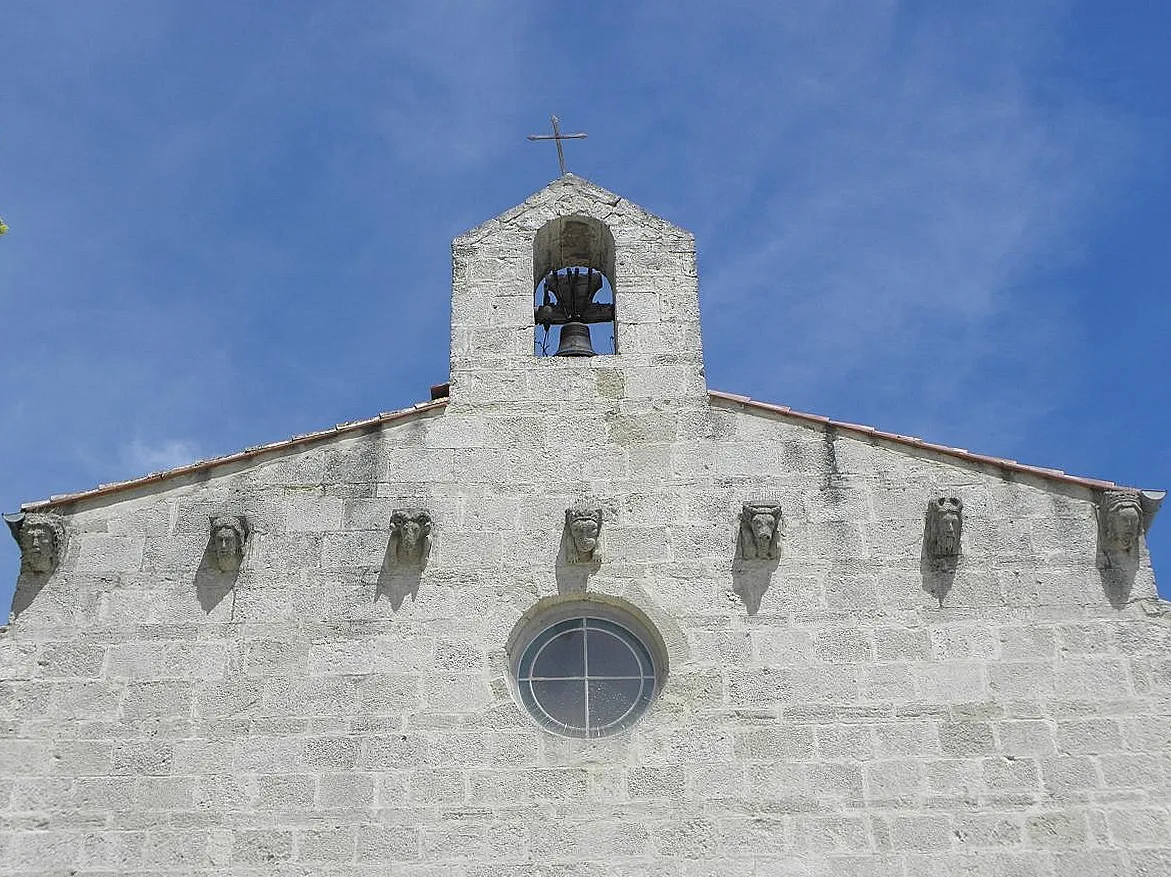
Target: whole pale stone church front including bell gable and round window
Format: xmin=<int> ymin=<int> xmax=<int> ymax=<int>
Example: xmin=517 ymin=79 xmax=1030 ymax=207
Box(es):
xmin=0 ymin=174 xmax=1171 ymax=877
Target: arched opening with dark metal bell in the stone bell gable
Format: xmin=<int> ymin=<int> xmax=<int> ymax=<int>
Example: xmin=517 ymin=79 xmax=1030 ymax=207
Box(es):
xmin=533 ymin=215 xmax=617 ymax=357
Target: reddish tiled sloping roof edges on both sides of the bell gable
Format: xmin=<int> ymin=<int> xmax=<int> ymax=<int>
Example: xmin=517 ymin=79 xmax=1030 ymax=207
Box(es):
xmin=21 ymin=384 xmax=1166 ymax=514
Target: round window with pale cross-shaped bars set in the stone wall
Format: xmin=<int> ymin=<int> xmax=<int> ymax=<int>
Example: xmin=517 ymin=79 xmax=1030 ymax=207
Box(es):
xmin=516 ymin=615 xmax=658 ymax=736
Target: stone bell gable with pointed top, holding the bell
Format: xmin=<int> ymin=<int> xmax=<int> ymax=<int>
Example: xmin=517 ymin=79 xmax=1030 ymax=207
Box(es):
xmin=451 ymin=174 xmax=707 ymax=409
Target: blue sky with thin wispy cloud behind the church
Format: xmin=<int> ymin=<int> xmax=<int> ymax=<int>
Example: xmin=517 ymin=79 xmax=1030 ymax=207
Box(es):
xmin=0 ymin=0 xmax=1171 ymax=605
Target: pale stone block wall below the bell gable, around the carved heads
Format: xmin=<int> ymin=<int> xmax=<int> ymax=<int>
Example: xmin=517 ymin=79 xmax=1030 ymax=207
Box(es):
xmin=0 ymin=395 xmax=1171 ymax=875
